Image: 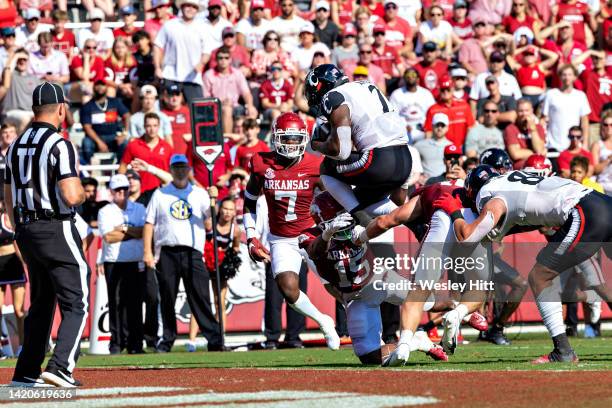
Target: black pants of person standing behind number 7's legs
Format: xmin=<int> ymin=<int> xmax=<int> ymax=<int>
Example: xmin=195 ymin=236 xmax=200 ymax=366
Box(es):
xmin=264 ymin=262 xmax=308 ymax=342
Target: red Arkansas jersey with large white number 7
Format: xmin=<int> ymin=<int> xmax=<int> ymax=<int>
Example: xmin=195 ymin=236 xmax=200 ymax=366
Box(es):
xmin=245 ymin=152 xmax=322 ymax=238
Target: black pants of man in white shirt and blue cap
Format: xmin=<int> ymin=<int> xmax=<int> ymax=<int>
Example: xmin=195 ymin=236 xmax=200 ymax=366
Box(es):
xmin=157 ymin=246 xmax=221 ymax=351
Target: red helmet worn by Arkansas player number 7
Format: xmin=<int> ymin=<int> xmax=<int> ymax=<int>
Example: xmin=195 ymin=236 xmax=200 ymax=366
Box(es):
xmin=272 ymin=112 xmax=308 ymax=159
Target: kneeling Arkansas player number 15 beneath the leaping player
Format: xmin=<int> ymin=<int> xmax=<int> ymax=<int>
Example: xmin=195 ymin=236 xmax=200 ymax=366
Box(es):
xmin=300 ymin=191 xmax=448 ymax=365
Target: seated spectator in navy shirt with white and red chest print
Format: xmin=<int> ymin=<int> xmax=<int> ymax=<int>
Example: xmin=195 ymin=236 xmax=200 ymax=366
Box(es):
xmin=80 ymin=79 xmax=130 ymax=163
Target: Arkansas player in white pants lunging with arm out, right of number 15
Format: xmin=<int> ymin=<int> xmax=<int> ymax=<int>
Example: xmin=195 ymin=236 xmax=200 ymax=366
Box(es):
xmin=353 ymin=182 xmax=489 ymax=365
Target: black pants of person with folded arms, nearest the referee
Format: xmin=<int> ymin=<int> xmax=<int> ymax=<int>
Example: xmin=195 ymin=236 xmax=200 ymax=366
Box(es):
xmin=104 ymin=262 xmax=146 ymax=352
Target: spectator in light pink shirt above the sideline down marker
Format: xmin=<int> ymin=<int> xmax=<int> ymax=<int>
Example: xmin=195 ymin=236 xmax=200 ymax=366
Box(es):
xmin=204 ymin=46 xmax=257 ymax=133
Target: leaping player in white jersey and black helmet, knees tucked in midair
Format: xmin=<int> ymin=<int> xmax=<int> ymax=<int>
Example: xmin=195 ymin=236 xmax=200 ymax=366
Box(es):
xmin=304 ymin=64 xmax=412 ymax=226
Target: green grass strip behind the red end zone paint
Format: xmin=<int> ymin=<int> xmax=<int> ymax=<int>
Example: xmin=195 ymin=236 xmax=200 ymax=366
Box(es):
xmin=0 ymin=332 xmax=612 ymax=371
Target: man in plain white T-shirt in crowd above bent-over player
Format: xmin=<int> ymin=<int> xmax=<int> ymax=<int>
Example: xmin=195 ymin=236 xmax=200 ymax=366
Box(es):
xmin=542 ymin=65 xmax=591 ymax=152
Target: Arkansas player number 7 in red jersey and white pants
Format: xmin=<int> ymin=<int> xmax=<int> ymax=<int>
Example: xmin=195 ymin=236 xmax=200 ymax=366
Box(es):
xmin=244 ymin=112 xmax=340 ymax=350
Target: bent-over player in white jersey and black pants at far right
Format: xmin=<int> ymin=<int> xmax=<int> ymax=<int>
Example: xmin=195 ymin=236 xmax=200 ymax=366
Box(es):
xmin=434 ymin=165 xmax=612 ymax=363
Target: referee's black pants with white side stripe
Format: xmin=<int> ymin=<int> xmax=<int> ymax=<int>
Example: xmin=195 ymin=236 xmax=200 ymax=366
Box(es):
xmin=15 ymin=220 xmax=91 ymax=379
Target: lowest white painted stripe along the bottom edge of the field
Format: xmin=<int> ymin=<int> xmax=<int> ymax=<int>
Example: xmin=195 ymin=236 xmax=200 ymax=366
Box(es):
xmin=3 ymin=388 xmax=439 ymax=408
